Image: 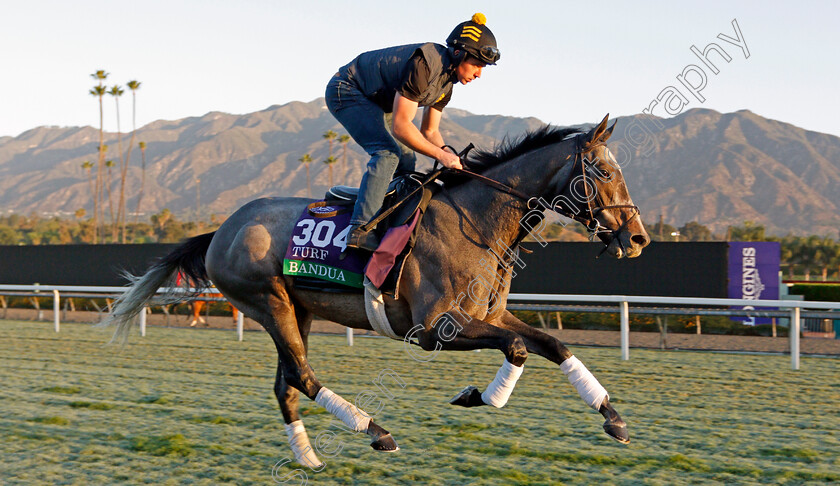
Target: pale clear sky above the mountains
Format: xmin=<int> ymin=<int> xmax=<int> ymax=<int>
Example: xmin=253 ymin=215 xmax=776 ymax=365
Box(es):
xmin=0 ymin=0 xmax=840 ymax=136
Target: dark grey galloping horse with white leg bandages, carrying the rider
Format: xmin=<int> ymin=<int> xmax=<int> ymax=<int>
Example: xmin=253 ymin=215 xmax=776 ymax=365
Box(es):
xmin=103 ymin=115 xmax=650 ymax=469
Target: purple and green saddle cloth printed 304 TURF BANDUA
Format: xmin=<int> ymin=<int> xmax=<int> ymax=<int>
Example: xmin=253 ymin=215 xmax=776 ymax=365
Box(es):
xmin=283 ymin=201 xmax=367 ymax=289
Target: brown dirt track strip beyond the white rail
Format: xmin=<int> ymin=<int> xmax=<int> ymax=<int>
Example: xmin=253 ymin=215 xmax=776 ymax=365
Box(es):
xmin=0 ymin=309 xmax=840 ymax=356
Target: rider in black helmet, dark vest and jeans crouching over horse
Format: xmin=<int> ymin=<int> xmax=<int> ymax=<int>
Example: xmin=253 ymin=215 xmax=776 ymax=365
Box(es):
xmin=326 ymin=13 xmax=501 ymax=251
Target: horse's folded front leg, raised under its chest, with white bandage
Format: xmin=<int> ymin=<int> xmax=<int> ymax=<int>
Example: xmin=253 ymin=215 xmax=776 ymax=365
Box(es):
xmin=409 ymin=313 xmax=528 ymax=408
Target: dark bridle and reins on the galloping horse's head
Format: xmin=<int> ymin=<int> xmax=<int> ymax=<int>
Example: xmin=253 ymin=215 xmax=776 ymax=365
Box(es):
xmin=443 ymin=133 xmax=641 ymax=256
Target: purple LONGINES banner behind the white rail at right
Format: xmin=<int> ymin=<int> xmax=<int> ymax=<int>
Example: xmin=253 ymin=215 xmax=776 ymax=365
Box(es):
xmin=728 ymin=241 xmax=781 ymax=326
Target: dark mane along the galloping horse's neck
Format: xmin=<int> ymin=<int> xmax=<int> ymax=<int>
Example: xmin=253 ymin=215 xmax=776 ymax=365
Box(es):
xmin=442 ymin=125 xmax=583 ymax=187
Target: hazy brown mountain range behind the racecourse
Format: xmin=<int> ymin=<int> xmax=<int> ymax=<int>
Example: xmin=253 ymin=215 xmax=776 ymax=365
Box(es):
xmin=0 ymin=99 xmax=840 ymax=237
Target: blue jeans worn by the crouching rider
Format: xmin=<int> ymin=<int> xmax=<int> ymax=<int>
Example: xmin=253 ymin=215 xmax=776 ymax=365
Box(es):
xmin=326 ymin=75 xmax=417 ymax=224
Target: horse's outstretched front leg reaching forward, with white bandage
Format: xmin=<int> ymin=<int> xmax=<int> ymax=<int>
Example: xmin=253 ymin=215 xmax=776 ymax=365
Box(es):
xmin=497 ymin=311 xmax=630 ymax=444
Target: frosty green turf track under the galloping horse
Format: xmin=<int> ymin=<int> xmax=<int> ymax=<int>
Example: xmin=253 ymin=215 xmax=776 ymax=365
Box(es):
xmin=0 ymin=321 xmax=840 ymax=485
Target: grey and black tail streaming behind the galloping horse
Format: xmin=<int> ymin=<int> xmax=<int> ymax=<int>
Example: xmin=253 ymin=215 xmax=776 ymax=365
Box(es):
xmin=100 ymin=231 xmax=215 ymax=343
